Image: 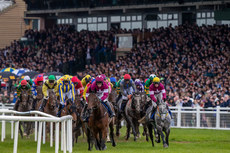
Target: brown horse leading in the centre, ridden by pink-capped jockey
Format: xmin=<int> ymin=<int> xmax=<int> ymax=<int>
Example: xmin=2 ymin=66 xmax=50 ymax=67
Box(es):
xmin=87 ymin=93 xmax=116 ymax=150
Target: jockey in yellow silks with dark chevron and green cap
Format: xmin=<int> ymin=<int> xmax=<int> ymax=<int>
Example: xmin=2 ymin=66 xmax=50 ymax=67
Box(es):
xmin=39 ymin=75 xmax=58 ymax=112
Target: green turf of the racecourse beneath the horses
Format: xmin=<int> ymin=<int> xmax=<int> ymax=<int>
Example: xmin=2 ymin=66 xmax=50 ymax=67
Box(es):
xmin=0 ymin=124 xmax=230 ymax=153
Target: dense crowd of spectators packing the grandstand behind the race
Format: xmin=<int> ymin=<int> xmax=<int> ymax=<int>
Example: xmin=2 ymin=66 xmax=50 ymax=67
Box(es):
xmin=0 ymin=25 xmax=230 ymax=107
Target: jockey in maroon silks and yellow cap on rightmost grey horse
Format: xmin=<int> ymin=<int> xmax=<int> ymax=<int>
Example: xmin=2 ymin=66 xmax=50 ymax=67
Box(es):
xmin=149 ymin=77 xmax=172 ymax=120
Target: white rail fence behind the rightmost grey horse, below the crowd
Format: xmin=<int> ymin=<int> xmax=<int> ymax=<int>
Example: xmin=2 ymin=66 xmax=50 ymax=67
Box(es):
xmin=170 ymin=106 xmax=230 ymax=130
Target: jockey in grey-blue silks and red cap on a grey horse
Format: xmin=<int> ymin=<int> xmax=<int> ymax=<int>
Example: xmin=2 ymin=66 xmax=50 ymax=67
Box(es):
xmin=120 ymin=74 xmax=137 ymax=112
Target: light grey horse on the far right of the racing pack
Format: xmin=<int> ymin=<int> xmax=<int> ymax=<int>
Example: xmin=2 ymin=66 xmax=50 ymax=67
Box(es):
xmin=148 ymin=94 xmax=171 ymax=148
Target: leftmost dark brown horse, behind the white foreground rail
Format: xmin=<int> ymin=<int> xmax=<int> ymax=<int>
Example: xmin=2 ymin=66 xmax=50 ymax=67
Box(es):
xmin=18 ymin=89 xmax=32 ymax=138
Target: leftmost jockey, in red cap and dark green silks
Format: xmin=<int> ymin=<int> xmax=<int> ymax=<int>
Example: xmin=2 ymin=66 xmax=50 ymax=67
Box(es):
xmin=14 ymin=80 xmax=31 ymax=111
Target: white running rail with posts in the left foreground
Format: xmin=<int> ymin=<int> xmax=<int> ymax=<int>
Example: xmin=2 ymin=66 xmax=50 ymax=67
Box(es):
xmin=0 ymin=109 xmax=72 ymax=153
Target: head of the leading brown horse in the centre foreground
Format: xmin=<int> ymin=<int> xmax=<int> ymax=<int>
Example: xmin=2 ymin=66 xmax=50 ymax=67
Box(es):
xmin=87 ymin=93 xmax=100 ymax=114
